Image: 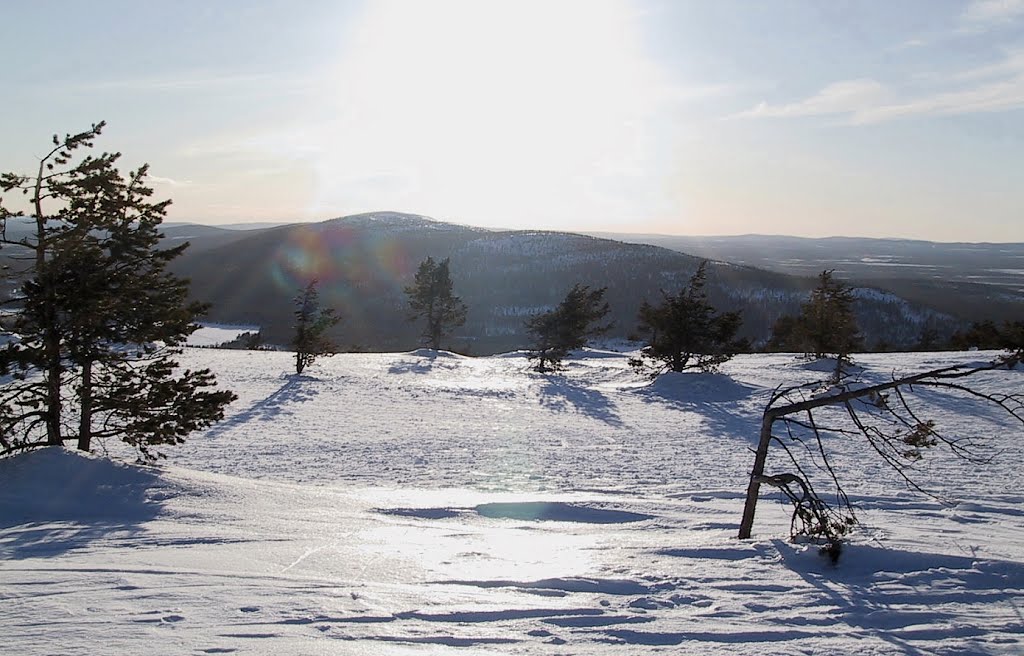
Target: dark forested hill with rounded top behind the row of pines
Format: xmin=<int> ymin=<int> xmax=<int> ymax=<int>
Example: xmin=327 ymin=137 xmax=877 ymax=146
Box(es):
xmin=168 ymin=212 xmax=956 ymax=353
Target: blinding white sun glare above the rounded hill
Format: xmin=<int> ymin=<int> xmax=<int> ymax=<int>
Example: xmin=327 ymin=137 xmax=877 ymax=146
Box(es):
xmin=297 ymin=0 xmax=668 ymax=224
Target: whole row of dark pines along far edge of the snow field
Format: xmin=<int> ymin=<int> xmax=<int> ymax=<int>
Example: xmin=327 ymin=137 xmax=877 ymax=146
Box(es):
xmin=201 ymin=244 xmax=1024 ymax=379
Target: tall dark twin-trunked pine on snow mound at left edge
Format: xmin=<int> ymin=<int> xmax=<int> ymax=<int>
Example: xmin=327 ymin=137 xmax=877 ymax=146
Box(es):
xmin=0 ymin=123 xmax=234 ymax=458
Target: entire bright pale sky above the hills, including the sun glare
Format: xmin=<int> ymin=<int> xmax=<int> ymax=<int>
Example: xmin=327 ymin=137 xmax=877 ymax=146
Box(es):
xmin=0 ymin=0 xmax=1024 ymax=242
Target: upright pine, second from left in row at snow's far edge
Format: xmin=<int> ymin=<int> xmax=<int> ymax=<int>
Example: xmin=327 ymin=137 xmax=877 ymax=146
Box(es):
xmin=406 ymin=257 xmax=466 ymax=351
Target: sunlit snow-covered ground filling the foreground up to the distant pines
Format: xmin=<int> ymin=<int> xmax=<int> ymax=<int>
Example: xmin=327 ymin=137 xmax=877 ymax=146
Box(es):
xmin=0 ymin=349 xmax=1024 ymax=656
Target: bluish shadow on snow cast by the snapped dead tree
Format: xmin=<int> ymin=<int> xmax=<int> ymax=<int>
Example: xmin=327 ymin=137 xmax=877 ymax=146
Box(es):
xmin=772 ymin=540 xmax=1024 ymax=655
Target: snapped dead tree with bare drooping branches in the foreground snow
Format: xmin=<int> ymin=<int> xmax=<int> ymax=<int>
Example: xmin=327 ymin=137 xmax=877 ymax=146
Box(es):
xmin=739 ymin=350 xmax=1024 ymax=558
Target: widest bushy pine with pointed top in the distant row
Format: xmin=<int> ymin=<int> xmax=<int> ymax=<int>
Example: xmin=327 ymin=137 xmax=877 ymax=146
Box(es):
xmin=631 ymin=262 xmax=746 ymax=376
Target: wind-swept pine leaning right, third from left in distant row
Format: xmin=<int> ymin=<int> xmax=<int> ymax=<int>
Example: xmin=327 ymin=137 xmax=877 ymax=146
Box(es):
xmin=526 ymin=285 xmax=611 ymax=373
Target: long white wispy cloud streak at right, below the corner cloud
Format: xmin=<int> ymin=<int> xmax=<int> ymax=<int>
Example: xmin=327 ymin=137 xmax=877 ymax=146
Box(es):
xmin=733 ymin=50 xmax=1024 ymax=125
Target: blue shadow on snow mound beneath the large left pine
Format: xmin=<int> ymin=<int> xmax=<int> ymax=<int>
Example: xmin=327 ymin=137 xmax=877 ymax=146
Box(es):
xmin=0 ymin=447 xmax=169 ymax=560
